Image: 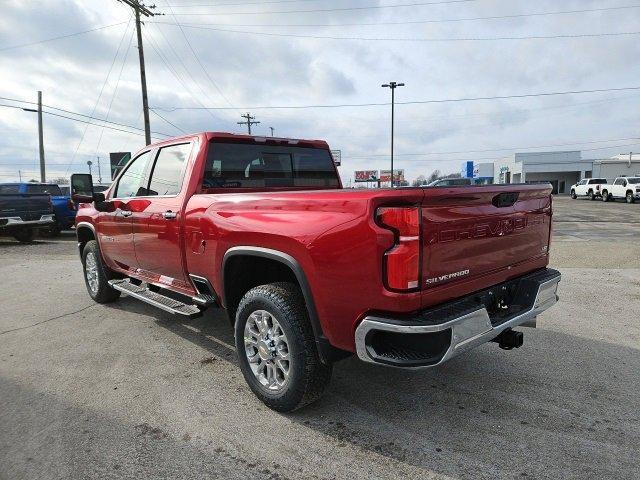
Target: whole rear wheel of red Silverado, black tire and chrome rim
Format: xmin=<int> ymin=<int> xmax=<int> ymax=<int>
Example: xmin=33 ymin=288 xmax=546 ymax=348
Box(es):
xmin=235 ymin=282 xmax=332 ymax=412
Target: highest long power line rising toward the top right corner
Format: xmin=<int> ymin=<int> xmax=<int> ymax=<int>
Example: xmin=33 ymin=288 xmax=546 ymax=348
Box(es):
xmin=164 ymin=5 xmax=640 ymax=28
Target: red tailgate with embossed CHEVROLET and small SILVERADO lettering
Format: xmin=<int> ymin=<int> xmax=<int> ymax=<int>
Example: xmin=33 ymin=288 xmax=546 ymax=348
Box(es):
xmin=421 ymin=184 xmax=551 ymax=295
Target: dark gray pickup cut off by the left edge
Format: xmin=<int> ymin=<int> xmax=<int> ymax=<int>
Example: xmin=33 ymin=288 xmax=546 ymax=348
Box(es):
xmin=0 ymin=185 xmax=55 ymax=243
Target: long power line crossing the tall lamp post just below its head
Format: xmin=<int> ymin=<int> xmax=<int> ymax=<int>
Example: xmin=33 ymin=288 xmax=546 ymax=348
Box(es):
xmin=155 ymin=86 xmax=640 ymax=112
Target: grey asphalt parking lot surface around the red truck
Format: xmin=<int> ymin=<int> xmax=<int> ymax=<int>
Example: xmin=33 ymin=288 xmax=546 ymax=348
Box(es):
xmin=0 ymin=197 xmax=640 ymax=480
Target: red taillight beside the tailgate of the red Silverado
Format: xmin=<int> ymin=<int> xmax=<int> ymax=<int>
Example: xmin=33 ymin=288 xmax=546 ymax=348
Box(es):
xmin=376 ymin=207 xmax=420 ymax=291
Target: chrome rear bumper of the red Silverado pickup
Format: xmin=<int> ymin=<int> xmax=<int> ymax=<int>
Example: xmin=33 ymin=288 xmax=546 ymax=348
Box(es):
xmin=355 ymin=269 xmax=561 ymax=368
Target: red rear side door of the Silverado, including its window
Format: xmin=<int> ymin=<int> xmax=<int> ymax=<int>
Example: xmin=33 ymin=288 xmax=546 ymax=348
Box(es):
xmin=133 ymin=142 xmax=192 ymax=288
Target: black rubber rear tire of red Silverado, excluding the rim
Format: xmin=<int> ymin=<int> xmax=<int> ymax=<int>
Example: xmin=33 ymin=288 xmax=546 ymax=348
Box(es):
xmin=235 ymin=282 xmax=332 ymax=412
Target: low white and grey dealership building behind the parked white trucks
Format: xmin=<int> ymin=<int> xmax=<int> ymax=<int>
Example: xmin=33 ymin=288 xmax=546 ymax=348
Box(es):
xmin=478 ymin=150 xmax=640 ymax=193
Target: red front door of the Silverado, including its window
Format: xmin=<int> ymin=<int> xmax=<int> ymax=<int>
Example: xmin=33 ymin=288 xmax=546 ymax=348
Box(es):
xmin=96 ymin=152 xmax=151 ymax=270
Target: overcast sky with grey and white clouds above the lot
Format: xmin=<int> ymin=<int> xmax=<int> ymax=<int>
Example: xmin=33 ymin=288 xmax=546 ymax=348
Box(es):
xmin=0 ymin=0 xmax=640 ymax=183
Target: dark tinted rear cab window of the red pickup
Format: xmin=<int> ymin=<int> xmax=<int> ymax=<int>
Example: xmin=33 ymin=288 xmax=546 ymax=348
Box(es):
xmin=202 ymin=142 xmax=339 ymax=189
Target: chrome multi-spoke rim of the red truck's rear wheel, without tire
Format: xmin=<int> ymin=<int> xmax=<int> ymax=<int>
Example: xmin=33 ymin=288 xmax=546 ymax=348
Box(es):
xmin=244 ymin=310 xmax=291 ymax=390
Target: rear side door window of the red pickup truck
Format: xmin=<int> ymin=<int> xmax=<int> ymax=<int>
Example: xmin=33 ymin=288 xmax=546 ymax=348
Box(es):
xmin=147 ymin=143 xmax=191 ymax=196
